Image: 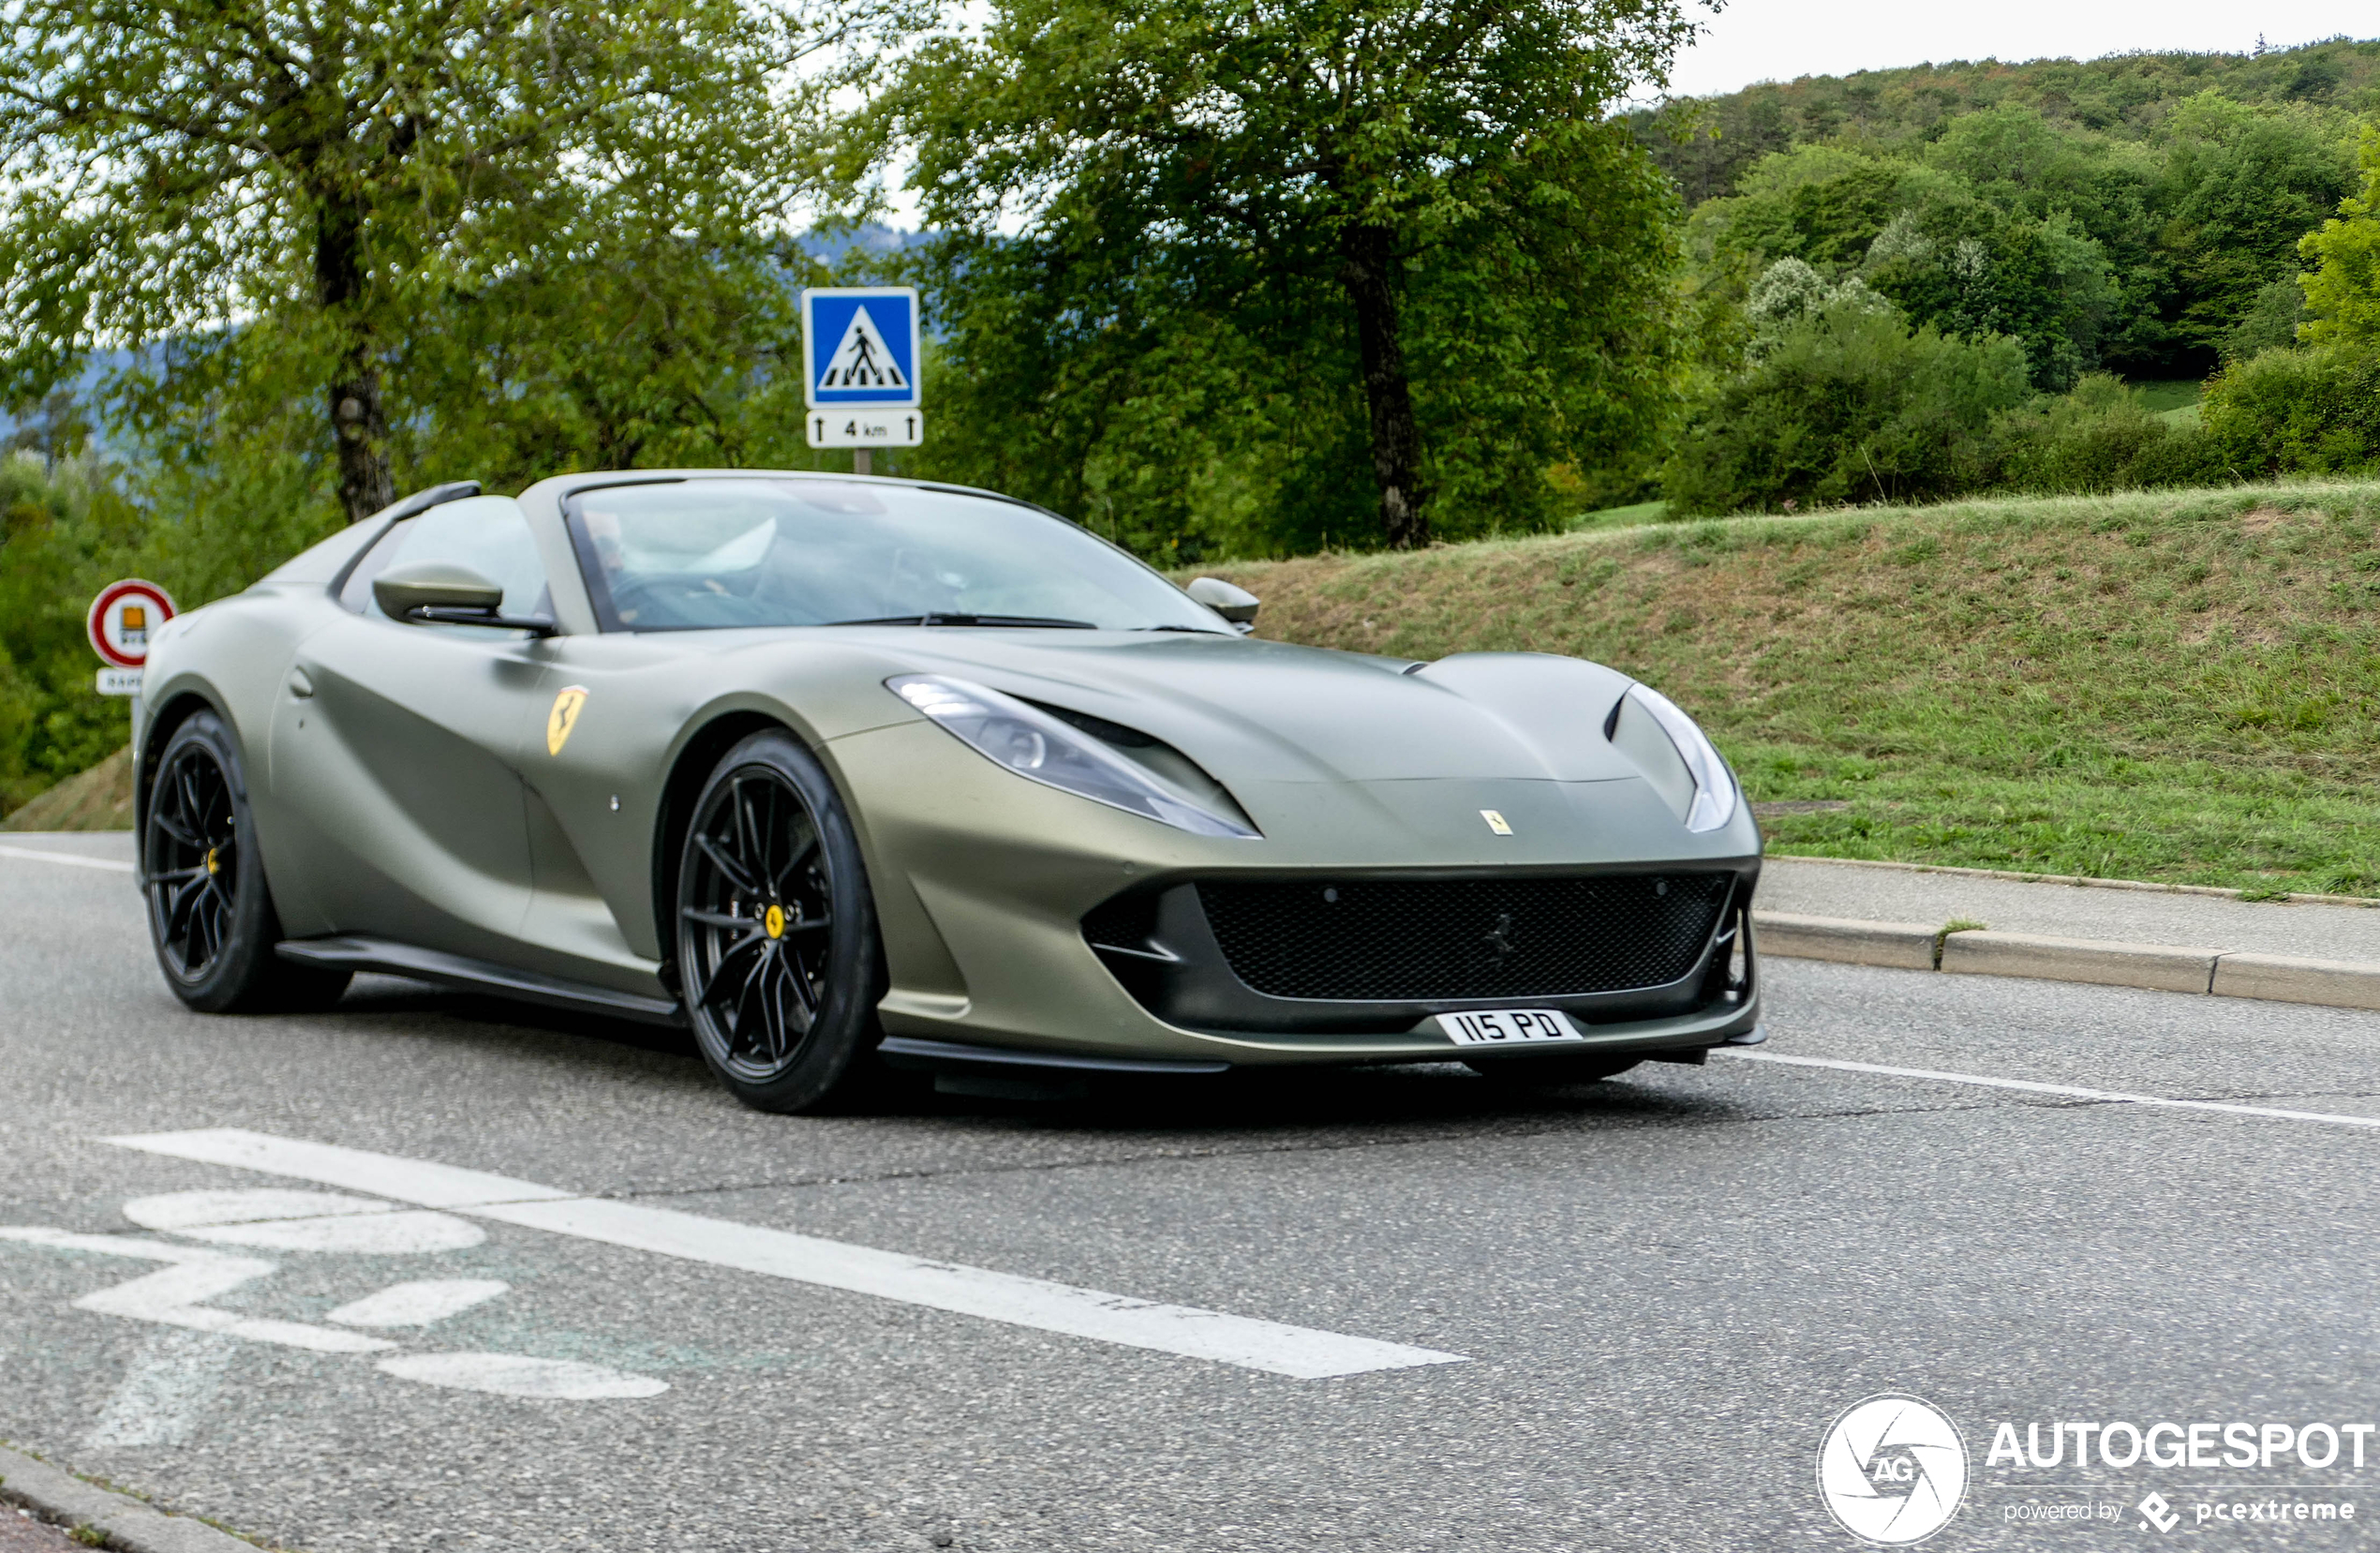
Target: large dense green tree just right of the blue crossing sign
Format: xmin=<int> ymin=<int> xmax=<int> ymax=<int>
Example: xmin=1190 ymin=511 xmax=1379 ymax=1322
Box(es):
xmin=878 ymin=0 xmax=1692 ymax=545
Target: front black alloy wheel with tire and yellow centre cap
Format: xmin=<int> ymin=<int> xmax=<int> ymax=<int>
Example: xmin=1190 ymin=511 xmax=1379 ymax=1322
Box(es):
xmin=678 ymin=731 xmax=883 ymax=1112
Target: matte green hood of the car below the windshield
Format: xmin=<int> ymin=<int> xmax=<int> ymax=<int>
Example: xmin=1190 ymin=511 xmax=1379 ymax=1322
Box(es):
xmin=842 ymin=631 xmax=1640 ymax=784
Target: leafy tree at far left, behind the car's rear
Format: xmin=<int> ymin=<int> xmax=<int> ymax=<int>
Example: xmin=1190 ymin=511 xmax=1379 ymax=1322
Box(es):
xmin=0 ymin=0 xmax=827 ymax=519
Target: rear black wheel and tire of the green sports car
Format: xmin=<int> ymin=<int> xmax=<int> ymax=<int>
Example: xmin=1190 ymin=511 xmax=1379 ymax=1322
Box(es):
xmin=141 ymin=712 xmax=350 ymax=1015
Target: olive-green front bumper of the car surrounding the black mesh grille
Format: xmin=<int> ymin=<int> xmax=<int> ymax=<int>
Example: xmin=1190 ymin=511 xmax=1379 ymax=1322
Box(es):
xmin=828 ymin=724 xmax=1762 ymax=1068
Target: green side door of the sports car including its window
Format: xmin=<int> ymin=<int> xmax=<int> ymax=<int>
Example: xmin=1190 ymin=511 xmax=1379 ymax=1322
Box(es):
xmin=272 ymin=496 xmax=550 ymax=960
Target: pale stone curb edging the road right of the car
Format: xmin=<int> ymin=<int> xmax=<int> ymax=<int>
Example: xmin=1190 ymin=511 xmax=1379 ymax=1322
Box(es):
xmin=1751 ymin=912 xmax=2380 ymax=1010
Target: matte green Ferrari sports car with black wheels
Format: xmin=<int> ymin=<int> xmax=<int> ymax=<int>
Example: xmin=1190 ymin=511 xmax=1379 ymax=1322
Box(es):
xmin=138 ymin=471 xmax=1762 ymax=1110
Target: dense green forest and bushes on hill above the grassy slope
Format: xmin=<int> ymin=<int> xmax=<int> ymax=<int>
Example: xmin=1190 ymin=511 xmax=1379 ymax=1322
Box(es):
xmin=1581 ymin=38 xmax=2380 ymax=512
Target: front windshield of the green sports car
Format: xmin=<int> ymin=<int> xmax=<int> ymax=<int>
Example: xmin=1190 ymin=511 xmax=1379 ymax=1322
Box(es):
xmin=569 ymin=476 xmax=1228 ymax=631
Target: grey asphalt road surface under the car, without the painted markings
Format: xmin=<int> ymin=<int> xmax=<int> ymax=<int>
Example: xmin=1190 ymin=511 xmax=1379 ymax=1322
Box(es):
xmin=0 ymin=839 xmax=2380 ymax=1553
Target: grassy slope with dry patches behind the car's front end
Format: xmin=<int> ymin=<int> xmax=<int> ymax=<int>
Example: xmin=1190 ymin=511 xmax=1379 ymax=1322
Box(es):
xmin=1212 ymin=481 xmax=2380 ymax=896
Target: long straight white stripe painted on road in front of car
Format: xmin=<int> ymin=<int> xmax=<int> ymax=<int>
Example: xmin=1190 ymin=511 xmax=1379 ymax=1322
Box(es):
xmin=107 ymin=1127 xmax=1466 ymax=1379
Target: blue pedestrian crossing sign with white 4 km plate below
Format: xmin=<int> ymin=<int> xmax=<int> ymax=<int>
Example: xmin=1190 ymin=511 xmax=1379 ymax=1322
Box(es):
xmin=802 ymin=286 xmax=926 ymax=474
